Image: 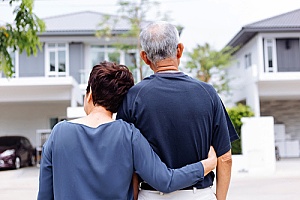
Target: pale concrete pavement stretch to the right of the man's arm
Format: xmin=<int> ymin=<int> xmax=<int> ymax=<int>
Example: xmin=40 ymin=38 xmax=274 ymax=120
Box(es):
xmin=228 ymin=158 xmax=300 ymax=200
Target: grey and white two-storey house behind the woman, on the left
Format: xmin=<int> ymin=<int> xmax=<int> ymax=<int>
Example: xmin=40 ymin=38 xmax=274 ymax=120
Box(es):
xmin=0 ymin=12 xmax=137 ymax=146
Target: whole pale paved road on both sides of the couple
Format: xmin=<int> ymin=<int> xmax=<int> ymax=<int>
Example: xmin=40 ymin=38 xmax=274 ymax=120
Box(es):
xmin=0 ymin=159 xmax=300 ymax=200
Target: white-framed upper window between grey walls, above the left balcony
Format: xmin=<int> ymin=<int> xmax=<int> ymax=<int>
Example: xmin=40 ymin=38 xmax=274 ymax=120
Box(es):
xmin=45 ymin=43 xmax=69 ymax=77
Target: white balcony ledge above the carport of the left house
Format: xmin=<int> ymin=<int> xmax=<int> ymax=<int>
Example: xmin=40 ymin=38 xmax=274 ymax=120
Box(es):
xmin=0 ymin=77 xmax=83 ymax=106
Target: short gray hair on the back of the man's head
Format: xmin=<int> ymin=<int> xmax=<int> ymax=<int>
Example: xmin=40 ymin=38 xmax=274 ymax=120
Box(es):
xmin=140 ymin=21 xmax=179 ymax=64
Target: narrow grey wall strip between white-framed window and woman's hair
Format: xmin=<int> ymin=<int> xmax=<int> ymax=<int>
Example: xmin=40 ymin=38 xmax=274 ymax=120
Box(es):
xmin=69 ymin=43 xmax=85 ymax=83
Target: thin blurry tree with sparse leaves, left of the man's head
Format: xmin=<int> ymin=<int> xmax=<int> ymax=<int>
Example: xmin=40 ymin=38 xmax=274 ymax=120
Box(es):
xmin=96 ymin=0 xmax=171 ymax=80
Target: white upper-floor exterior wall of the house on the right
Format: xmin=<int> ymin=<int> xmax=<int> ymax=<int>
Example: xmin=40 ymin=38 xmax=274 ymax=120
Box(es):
xmin=228 ymin=33 xmax=300 ymax=116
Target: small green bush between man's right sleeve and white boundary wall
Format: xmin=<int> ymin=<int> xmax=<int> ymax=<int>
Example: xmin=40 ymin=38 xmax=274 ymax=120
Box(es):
xmin=227 ymin=104 xmax=254 ymax=154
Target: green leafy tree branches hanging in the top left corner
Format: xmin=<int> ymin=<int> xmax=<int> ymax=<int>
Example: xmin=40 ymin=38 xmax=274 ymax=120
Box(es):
xmin=0 ymin=0 xmax=45 ymax=77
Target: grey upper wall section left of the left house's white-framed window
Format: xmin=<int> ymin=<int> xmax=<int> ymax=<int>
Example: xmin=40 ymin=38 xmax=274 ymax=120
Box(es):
xmin=19 ymin=47 xmax=45 ymax=77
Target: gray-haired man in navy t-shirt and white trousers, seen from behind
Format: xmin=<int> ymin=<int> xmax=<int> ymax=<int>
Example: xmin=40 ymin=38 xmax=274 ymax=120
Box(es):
xmin=117 ymin=22 xmax=238 ymax=200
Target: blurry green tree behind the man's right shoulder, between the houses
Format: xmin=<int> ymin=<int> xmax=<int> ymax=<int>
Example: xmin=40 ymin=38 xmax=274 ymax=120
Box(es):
xmin=187 ymin=43 xmax=237 ymax=94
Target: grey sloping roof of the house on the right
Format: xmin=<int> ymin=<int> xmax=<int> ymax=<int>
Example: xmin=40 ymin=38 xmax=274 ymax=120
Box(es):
xmin=226 ymin=9 xmax=300 ymax=47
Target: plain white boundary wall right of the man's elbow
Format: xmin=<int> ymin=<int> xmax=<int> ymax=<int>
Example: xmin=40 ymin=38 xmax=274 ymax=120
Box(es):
xmin=232 ymin=117 xmax=276 ymax=175
